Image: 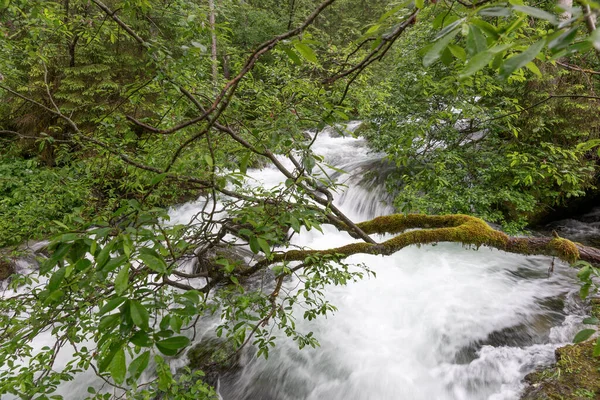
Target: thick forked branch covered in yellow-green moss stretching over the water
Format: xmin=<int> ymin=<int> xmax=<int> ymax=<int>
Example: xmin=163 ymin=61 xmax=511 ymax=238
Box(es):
xmin=251 ymin=214 xmax=600 ymax=270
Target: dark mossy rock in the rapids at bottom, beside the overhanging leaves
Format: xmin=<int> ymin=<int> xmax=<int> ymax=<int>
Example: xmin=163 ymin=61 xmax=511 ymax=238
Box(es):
xmin=187 ymin=338 xmax=240 ymax=386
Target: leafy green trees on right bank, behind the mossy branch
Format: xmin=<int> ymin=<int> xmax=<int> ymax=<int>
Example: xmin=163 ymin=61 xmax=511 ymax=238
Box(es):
xmin=365 ymin=6 xmax=600 ymax=229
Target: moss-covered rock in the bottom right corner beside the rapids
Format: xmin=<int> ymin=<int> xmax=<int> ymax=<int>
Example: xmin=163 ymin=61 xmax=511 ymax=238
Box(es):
xmin=521 ymin=340 xmax=600 ymax=400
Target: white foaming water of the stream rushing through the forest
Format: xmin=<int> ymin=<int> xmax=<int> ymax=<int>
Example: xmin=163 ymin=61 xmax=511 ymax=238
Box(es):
xmin=1 ymin=125 xmax=596 ymax=400
